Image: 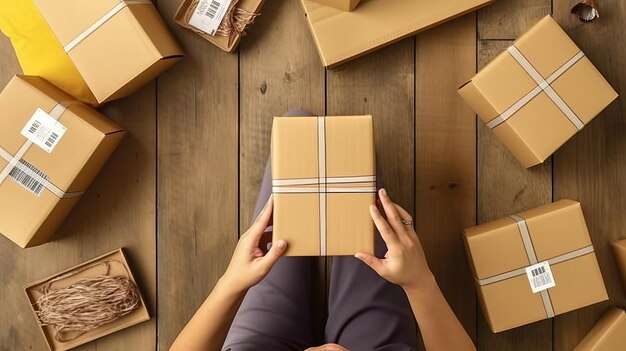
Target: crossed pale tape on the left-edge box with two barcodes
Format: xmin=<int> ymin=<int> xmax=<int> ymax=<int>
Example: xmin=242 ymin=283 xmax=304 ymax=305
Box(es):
xmin=0 ymin=103 xmax=84 ymax=199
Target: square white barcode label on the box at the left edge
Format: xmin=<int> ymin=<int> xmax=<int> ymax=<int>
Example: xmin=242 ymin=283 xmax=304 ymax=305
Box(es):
xmin=22 ymin=108 xmax=67 ymax=153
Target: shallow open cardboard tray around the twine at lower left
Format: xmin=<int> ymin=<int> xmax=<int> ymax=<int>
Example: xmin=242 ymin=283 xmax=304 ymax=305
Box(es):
xmin=24 ymin=249 xmax=150 ymax=351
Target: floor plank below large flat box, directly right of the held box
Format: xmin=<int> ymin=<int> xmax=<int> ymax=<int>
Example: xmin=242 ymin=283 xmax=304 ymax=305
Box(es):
xmin=326 ymin=31 xmax=415 ymax=346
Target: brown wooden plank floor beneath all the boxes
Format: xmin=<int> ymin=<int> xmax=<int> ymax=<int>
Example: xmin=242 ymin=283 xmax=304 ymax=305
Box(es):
xmin=0 ymin=0 xmax=626 ymax=351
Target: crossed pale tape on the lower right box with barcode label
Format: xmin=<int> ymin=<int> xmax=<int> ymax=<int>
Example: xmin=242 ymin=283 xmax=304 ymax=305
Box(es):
xmin=477 ymin=215 xmax=594 ymax=318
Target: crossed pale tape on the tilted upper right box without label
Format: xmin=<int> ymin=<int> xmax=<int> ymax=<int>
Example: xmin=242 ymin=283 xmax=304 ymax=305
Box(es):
xmin=487 ymin=45 xmax=585 ymax=130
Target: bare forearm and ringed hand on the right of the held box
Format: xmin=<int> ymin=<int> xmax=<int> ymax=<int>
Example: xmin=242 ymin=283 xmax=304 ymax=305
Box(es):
xmin=355 ymin=189 xmax=476 ymax=351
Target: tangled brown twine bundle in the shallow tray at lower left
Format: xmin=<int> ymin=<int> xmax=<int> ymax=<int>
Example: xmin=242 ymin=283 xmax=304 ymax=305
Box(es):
xmin=36 ymin=260 xmax=141 ymax=342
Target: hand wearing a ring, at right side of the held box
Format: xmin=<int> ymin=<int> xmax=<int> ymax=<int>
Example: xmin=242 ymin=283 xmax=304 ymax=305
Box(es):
xmin=355 ymin=189 xmax=432 ymax=290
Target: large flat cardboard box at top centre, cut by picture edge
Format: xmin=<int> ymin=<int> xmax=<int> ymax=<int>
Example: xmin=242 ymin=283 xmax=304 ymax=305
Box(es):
xmin=300 ymin=0 xmax=493 ymax=68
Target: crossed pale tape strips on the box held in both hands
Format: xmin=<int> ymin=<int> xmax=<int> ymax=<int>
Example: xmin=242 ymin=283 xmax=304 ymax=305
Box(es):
xmin=272 ymin=116 xmax=376 ymax=256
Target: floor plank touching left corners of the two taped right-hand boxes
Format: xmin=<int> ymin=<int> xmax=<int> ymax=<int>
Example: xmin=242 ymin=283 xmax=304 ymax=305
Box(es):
xmin=415 ymin=13 xmax=476 ymax=346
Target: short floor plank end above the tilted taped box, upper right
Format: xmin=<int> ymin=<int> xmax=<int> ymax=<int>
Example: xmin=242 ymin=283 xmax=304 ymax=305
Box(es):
xmin=478 ymin=0 xmax=552 ymax=40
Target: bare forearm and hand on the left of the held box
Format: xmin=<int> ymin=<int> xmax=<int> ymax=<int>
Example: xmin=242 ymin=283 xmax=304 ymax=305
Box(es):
xmin=170 ymin=198 xmax=287 ymax=351
